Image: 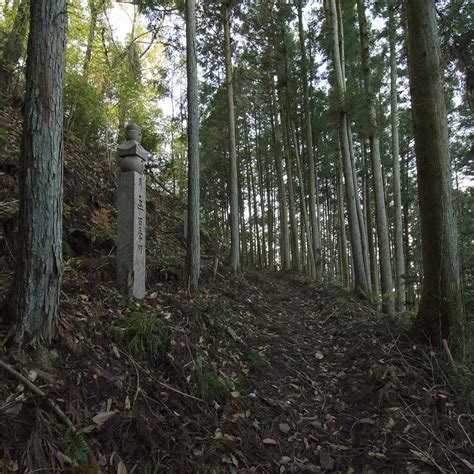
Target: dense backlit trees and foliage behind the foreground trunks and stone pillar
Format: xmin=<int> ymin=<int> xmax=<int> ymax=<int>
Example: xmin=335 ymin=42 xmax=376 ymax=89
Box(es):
xmin=1 ymin=0 xmax=474 ymax=313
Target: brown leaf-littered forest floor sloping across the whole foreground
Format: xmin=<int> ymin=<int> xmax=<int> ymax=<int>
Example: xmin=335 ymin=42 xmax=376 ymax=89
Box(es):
xmin=0 ymin=268 xmax=474 ymax=473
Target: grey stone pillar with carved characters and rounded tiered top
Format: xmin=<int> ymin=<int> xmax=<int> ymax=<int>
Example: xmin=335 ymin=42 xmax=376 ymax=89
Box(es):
xmin=117 ymin=123 xmax=148 ymax=299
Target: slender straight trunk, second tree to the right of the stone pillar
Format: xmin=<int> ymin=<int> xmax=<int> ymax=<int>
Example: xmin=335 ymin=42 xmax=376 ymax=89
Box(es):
xmin=223 ymin=0 xmax=240 ymax=273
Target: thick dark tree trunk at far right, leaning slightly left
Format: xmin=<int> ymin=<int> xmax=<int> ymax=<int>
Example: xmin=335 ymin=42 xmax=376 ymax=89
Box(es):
xmin=406 ymin=0 xmax=465 ymax=356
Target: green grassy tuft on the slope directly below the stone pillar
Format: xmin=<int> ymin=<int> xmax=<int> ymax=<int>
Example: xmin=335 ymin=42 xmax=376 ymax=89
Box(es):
xmin=111 ymin=312 xmax=168 ymax=358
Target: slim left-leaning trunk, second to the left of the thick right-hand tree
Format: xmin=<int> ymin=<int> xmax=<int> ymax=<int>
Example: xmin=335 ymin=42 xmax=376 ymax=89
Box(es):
xmin=357 ymin=0 xmax=395 ymax=314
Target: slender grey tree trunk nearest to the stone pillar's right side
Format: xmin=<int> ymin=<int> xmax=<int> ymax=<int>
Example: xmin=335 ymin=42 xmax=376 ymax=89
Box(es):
xmin=186 ymin=0 xmax=201 ymax=291
